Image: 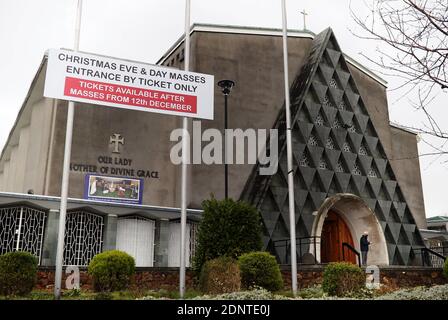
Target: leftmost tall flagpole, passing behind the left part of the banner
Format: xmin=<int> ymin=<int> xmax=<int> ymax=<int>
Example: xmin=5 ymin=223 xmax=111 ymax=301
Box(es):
xmin=54 ymin=0 xmax=82 ymax=299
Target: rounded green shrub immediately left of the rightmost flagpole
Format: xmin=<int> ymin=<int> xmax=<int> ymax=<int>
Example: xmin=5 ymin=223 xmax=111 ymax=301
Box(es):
xmin=238 ymin=252 xmax=283 ymax=291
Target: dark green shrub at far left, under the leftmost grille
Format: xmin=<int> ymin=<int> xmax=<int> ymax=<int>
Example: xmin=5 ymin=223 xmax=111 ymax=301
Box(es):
xmin=0 ymin=251 xmax=37 ymax=296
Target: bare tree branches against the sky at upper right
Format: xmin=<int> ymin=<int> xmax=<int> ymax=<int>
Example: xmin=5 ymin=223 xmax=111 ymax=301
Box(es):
xmin=350 ymin=0 xmax=448 ymax=142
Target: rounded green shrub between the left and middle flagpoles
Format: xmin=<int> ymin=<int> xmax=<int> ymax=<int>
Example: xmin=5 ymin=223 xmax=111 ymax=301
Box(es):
xmin=88 ymin=250 xmax=135 ymax=292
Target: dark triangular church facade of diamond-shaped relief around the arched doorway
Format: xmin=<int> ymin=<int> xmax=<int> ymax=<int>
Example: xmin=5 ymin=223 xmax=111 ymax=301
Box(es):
xmin=242 ymin=29 xmax=424 ymax=265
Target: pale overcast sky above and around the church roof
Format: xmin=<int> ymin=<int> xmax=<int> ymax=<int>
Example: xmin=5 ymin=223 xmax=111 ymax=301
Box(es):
xmin=0 ymin=0 xmax=448 ymax=216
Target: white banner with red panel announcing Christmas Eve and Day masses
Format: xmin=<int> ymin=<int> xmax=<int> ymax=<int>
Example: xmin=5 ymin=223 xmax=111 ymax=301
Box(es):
xmin=44 ymin=49 xmax=214 ymax=119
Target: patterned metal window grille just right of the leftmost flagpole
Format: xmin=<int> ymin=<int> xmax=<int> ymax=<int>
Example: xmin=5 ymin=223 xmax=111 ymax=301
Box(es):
xmin=64 ymin=211 xmax=104 ymax=266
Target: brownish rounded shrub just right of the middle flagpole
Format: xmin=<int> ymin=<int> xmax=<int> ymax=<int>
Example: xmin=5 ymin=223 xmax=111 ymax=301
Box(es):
xmin=199 ymin=257 xmax=241 ymax=294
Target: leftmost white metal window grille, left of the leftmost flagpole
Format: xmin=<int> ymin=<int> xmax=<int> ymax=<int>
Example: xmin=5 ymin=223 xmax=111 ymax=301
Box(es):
xmin=0 ymin=206 xmax=46 ymax=263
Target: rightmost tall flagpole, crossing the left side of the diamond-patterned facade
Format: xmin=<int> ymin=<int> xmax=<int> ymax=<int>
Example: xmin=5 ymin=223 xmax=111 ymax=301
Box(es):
xmin=282 ymin=0 xmax=297 ymax=295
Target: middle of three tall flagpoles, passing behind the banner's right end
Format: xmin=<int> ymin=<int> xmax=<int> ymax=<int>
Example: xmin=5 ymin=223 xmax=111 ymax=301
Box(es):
xmin=179 ymin=0 xmax=190 ymax=298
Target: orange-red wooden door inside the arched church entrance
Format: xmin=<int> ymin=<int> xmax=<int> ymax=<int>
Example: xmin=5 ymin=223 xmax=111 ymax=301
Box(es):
xmin=320 ymin=210 xmax=356 ymax=264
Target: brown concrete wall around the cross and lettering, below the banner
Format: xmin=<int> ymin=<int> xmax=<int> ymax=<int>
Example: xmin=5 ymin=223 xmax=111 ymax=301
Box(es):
xmin=47 ymin=101 xmax=177 ymax=206
